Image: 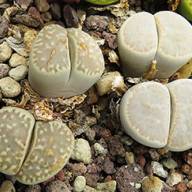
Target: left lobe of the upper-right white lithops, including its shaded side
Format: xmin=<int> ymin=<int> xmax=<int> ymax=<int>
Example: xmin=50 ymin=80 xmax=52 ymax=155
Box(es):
xmin=118 ymin=12 xmax=158 ymax=76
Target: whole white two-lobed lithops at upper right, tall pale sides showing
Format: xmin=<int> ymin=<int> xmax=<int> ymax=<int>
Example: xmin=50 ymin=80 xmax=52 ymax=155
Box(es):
xmin=118 ymin=11 xmax=192 ymax=78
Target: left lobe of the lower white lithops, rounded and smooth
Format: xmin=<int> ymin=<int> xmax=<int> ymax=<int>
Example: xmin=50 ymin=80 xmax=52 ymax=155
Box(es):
xmin=120 ymin=82 xmax=170 ymax=148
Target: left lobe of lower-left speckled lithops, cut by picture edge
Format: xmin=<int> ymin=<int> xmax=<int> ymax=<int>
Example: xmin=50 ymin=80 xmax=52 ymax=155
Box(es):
xmin=0 ymin=107 xmax=35 ymax=175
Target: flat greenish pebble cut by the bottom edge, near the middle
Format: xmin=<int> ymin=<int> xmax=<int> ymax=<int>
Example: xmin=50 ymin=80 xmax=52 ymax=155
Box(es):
xmin=96 ymin=180 xmax=117 ymax=192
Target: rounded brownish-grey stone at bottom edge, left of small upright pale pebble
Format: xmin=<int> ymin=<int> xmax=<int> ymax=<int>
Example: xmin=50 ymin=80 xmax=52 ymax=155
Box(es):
xmin=45 ymin=180 xmax=70 ymax=192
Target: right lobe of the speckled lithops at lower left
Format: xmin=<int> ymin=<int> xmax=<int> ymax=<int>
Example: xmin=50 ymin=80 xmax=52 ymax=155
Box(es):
xmin=16 ymin=120 xmax=74 ymax=184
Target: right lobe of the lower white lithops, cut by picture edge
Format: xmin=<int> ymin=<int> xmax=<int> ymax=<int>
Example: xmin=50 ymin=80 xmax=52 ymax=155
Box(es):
xmin=167 ymin=79 xmax=192 ymax=151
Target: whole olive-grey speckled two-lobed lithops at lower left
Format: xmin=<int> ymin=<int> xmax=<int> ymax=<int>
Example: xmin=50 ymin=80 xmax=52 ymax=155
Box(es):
xmin=0 ymin=107 xmax=74 ymax=185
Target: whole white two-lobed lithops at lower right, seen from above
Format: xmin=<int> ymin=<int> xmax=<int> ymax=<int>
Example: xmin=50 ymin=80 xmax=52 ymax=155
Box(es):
xmin=120 ymin=79 xmax=192 ymax=151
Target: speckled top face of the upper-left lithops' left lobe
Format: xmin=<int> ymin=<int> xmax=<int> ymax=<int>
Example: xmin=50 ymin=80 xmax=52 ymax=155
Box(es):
xmin=30 ymin=25 xmax=70 ymax=73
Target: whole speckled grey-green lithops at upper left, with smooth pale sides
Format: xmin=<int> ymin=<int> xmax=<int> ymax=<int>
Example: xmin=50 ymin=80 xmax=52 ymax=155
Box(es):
xmin=29 ymin=24 xmax=104 ymax=97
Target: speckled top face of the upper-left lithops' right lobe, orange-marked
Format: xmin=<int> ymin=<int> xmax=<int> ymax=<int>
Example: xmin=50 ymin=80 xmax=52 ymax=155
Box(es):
xmin=68 ymin=29 xmax=104 ymax=78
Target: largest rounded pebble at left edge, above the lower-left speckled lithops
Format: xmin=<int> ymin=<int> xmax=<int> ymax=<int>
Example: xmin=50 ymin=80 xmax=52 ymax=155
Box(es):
xmin=0 ymin=77 xmax=21 ymax=98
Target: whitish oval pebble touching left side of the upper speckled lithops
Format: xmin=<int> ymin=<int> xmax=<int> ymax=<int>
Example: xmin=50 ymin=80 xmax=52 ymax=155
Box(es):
xmin=9 ymin=65 xmax=28 ymax=81
